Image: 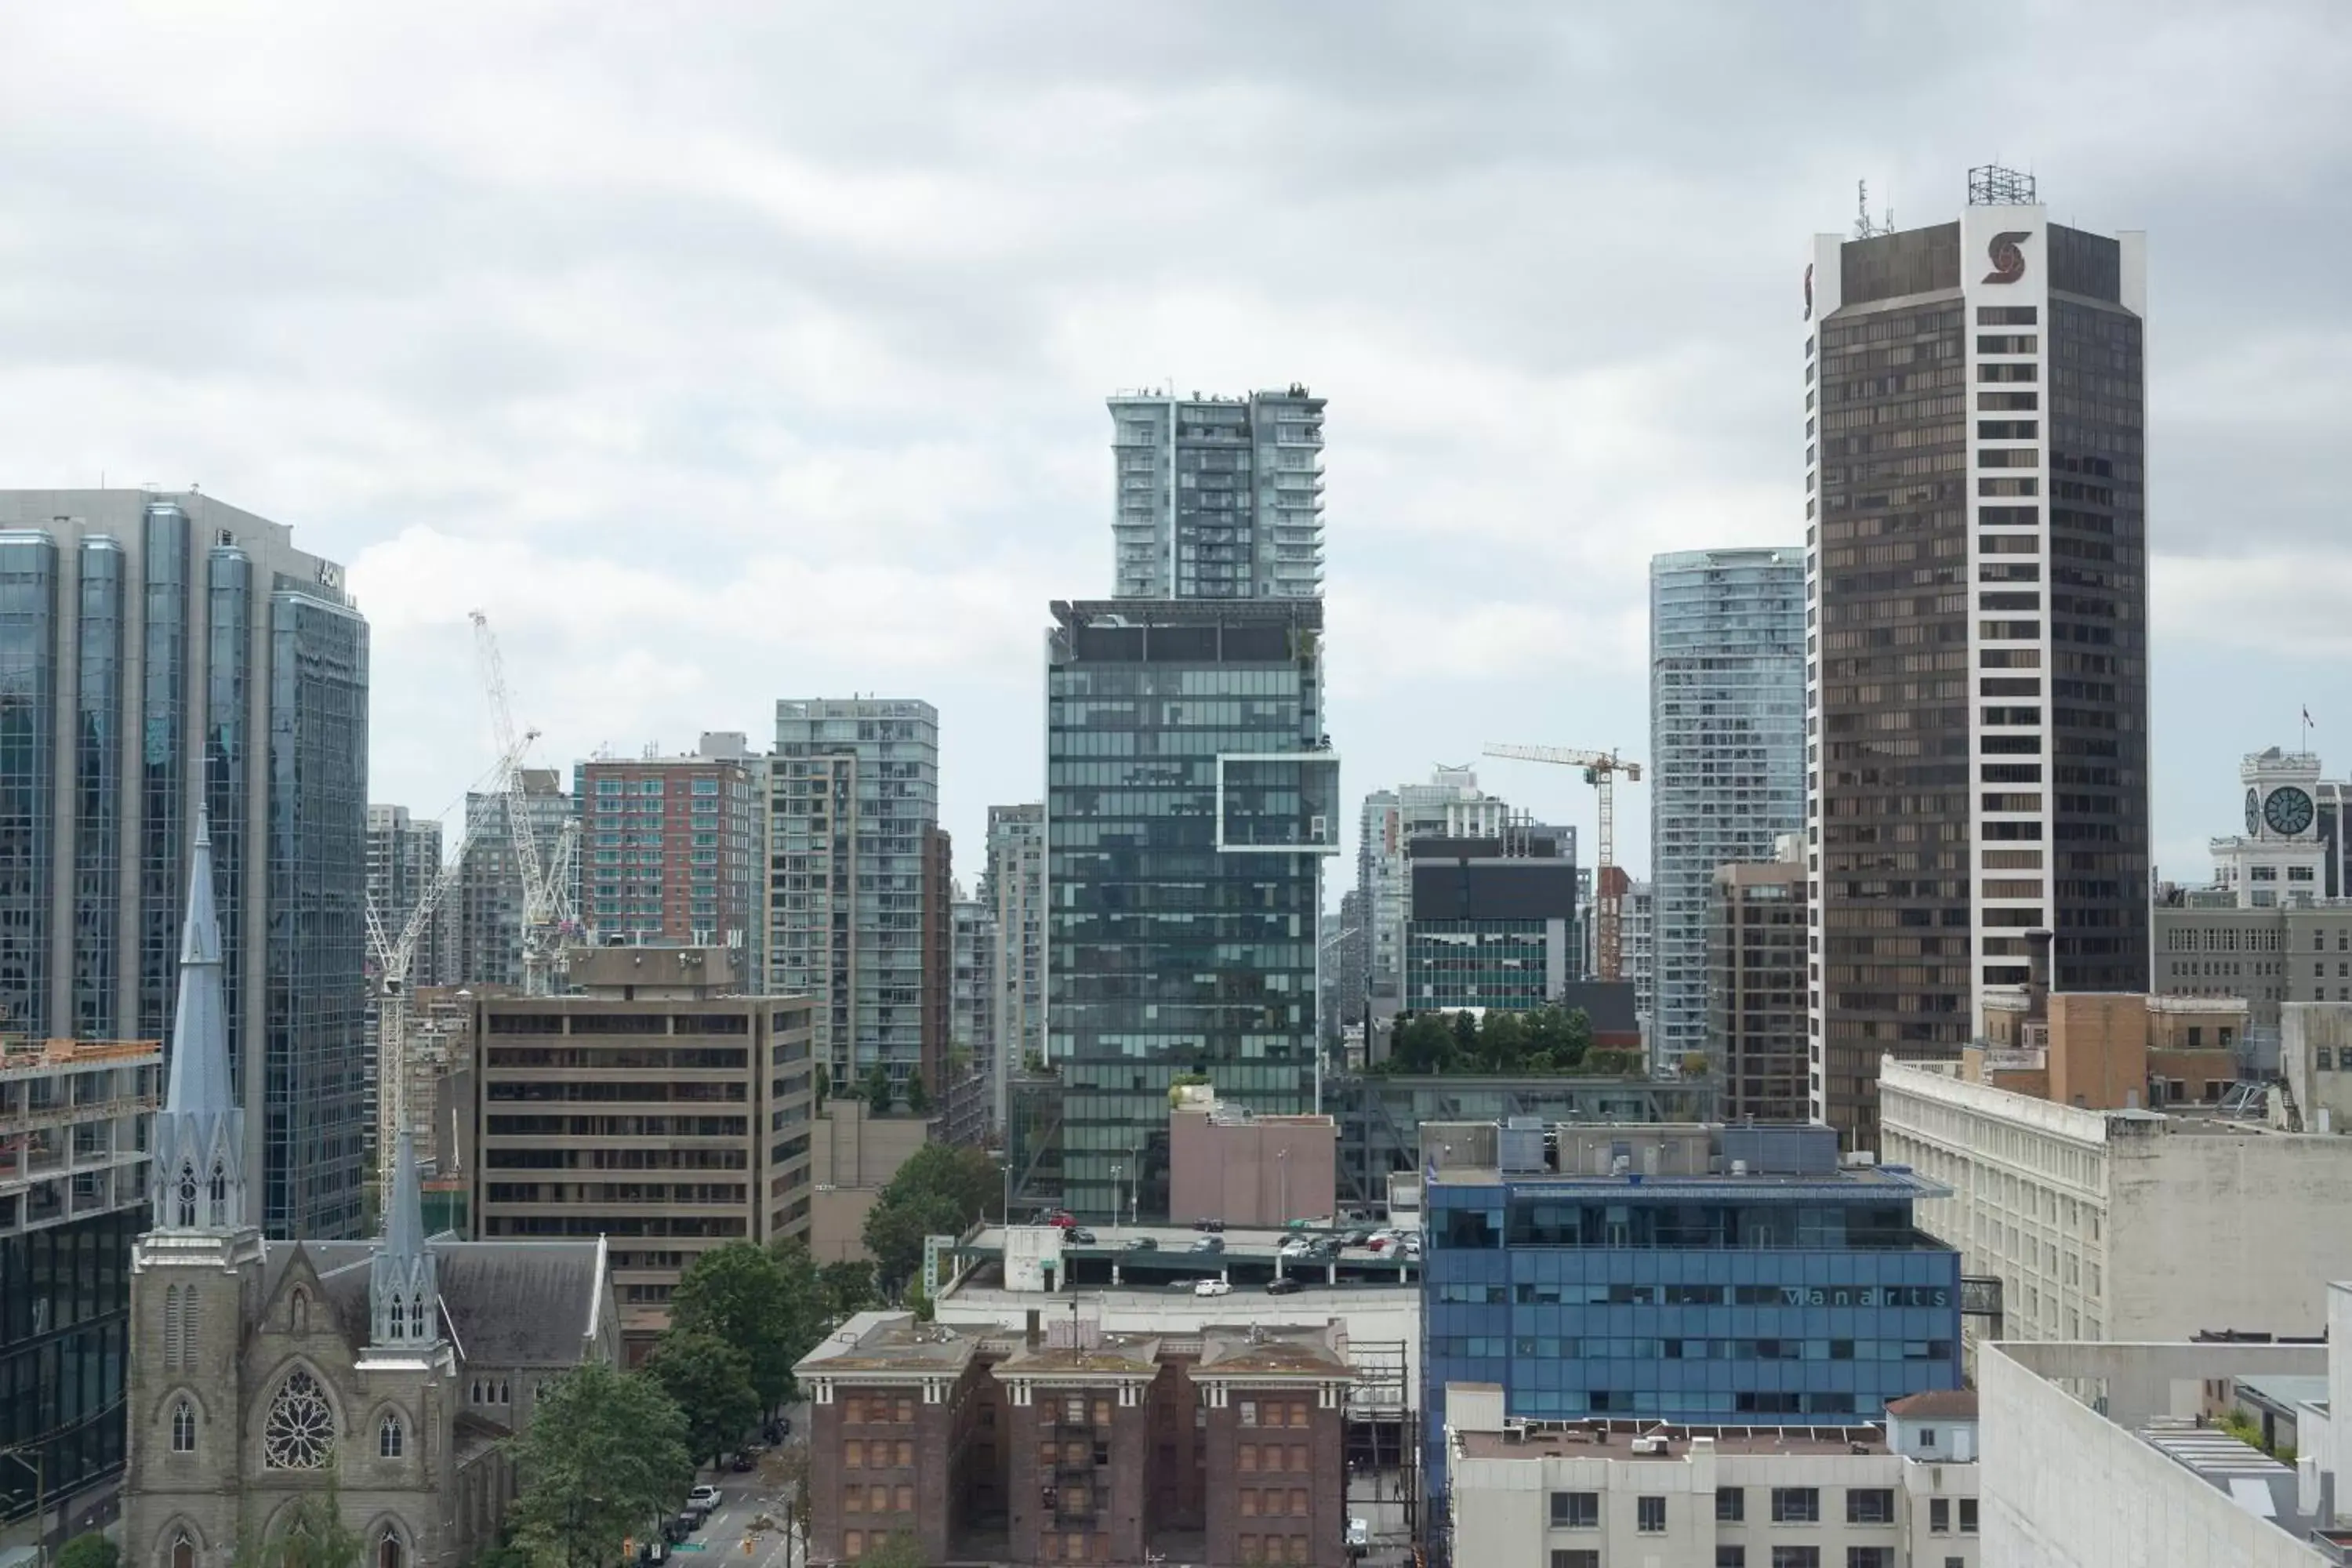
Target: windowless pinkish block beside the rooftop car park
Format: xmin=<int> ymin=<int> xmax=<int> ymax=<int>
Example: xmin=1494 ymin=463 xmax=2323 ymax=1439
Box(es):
xmin=1167 ymin=1088 xmax=1338 ymax=1227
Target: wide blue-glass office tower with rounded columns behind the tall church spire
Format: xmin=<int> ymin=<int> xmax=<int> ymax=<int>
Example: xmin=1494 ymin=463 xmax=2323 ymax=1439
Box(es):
xmin=0 ymin=489 xmax=367 ymax=1239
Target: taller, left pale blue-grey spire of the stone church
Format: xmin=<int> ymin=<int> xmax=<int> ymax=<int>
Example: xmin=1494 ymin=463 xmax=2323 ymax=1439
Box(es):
xmin=151 ymin=811 xmax=245 ymax=1234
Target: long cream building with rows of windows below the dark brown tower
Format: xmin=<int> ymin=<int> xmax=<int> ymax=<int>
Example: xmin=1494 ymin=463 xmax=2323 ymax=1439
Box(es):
xmin=1879 ymin=1058 xmax=2352 ymax=1345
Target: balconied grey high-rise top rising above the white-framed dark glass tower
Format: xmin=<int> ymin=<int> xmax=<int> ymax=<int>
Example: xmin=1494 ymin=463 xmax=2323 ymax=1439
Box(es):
xmin=1110 ymin=386 xmax=1324 ymax=600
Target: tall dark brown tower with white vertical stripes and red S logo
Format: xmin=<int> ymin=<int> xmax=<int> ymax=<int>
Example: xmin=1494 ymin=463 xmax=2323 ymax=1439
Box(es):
xmin=1804 ymin=167 xmax=2147 ymax=1147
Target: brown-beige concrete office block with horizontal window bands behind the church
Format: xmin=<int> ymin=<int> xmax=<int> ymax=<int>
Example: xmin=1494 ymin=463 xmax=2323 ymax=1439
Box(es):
xmin=473 ymin=947 xmax=811 ymax=1361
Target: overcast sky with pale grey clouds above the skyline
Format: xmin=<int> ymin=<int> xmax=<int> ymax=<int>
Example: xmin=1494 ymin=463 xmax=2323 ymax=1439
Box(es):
xmin=0 ymin=0 xmax=2352 ymax=881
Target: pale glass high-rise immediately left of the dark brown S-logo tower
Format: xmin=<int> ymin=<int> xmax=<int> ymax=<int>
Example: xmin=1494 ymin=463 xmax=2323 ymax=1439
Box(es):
xmin=1649 ymin=546 xmax=1804 ymax=1062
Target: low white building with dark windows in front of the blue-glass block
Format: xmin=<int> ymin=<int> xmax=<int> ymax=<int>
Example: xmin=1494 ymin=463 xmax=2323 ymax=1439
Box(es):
xmin=1446 ymin=1382 xmax=1978 ymax=1568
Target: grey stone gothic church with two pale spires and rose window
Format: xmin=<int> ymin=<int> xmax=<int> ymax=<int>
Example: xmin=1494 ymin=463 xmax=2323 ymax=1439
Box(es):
xmin=122 ymin=822 xmax=619 ymax=1568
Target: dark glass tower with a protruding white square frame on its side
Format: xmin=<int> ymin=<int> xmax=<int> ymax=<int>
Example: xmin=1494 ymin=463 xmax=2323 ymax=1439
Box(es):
xmin=1049 ymin=600 xmax=1338 ymax=1218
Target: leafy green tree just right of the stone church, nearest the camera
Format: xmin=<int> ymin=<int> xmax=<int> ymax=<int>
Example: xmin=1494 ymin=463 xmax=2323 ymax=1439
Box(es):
xmin=506 ymin=1361 xmax=694 ymax=1568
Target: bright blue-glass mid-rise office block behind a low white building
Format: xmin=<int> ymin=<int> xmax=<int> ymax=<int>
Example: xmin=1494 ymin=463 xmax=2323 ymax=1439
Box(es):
xmin=1421 ymin=1126 xmax=1959 ymax=1497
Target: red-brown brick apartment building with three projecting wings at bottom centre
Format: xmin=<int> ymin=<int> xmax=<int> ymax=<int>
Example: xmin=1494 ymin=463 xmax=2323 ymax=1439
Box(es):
xmin=797 ymin=1312 xmax=1352 ymax=1568
